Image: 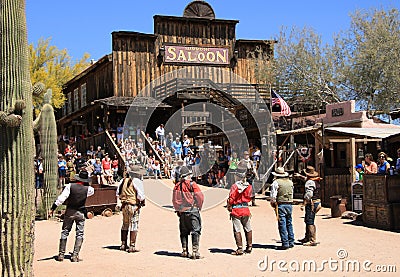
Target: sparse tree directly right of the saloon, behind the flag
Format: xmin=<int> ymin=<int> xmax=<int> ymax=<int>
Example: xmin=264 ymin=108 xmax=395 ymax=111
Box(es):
xmin=256 ymin=27 xmax=340 ymax=109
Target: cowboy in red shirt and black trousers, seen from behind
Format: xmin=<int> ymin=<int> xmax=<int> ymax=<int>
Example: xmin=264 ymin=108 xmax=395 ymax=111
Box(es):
xmin=172 ymin=166 xmax=204 ymax=259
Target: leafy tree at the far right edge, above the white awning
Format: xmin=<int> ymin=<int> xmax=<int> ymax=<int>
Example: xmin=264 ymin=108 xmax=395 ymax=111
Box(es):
xmin=334 ymin=9 xmax=400 ymax=113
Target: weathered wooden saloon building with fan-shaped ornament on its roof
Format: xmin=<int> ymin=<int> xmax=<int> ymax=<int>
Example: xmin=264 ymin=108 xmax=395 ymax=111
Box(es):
xmin=57 ymin=1 xmax=276 ymax=147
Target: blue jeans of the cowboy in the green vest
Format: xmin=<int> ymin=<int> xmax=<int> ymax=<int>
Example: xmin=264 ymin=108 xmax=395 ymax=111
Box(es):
xmin=278 ymin=204 xmax=294 ymax=247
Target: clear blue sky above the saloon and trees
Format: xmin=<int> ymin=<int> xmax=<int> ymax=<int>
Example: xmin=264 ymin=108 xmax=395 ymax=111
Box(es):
xmin=26 ymin=0 xmax=400 ymax=60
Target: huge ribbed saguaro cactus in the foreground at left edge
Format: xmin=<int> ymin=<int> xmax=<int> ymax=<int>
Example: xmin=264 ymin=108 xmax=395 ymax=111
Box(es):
xmin=0 ymin=0 xmax=35 ymax=276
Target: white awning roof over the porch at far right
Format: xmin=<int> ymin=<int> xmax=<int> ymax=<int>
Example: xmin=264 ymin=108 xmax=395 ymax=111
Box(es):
xmin=325 ymin=127 xmax=400 ymax=139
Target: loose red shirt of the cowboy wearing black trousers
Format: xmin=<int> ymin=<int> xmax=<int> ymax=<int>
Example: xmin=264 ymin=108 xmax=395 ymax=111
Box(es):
xmin=172 ymin=180 xmax=204 ymax=212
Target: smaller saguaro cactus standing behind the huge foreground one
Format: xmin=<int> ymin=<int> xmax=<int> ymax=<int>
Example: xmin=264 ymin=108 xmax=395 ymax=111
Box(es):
xmin=33 ymin=89 xmax=58 ymax=219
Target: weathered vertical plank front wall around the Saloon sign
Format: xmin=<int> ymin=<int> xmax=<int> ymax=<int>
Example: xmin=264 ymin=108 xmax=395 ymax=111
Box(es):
xmin=113 ymin=16 xmax=276 ymax=96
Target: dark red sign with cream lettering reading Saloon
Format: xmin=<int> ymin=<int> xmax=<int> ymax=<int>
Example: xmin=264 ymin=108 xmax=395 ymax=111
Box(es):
xmin=164 ymin=45 xmax=229 ymax=65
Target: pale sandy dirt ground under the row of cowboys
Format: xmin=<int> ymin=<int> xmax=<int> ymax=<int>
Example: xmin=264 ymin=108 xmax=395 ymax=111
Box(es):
xmin=34 ymin=180 xmax=400 ymax=277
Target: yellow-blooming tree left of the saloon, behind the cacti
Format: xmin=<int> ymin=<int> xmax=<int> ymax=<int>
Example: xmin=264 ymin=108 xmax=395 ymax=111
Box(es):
xmin=29 ymin=39 xmax=89 ymax=111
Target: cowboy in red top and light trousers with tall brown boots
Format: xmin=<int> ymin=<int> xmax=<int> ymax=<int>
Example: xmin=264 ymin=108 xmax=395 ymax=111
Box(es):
xmin=227 ymin=161 xmax=253 ymax=255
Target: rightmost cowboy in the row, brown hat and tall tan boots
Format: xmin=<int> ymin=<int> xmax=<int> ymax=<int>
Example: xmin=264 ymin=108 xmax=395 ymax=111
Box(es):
xmin=299 ymin=166 xmax=321 ymax=246
